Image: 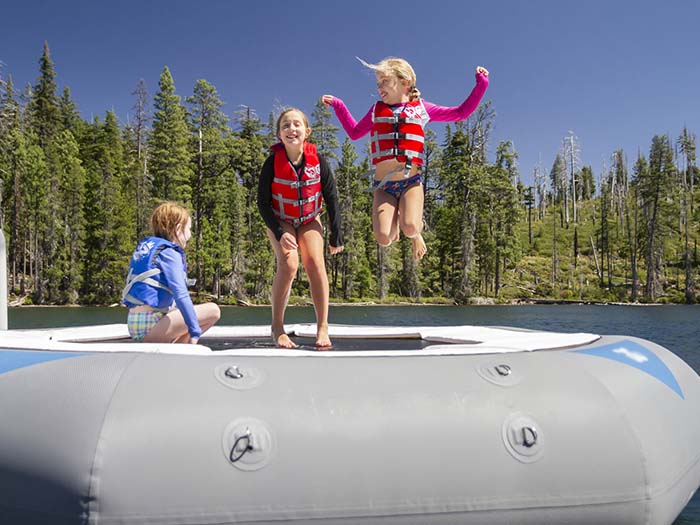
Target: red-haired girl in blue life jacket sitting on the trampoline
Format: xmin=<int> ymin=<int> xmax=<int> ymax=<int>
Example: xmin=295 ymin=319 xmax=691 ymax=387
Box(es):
xmin=122 ymin=202 xmax=221 ymax=344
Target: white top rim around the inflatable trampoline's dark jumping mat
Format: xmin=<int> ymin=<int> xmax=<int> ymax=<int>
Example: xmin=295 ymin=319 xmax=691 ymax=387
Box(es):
xmin=0 ymin=324 xmax=600 ymax=357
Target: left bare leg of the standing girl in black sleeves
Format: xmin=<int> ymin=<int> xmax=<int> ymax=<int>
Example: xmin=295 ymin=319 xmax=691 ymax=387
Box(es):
xmin=267 ymin=223 xmax=299 ymax=348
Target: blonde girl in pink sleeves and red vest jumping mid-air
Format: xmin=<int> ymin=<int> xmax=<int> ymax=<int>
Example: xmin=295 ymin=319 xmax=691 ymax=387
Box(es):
xmin=321 ymin=57 xmax=489 ymax=260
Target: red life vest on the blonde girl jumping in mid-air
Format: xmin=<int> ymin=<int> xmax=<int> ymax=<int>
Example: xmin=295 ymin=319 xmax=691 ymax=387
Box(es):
xmin=370 ymin=99 xmax=429 ymax=166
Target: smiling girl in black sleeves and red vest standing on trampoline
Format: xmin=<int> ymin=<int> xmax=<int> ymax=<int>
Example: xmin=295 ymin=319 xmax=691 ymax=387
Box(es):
xmin=258 ymin=108 xmax=343 ymax=348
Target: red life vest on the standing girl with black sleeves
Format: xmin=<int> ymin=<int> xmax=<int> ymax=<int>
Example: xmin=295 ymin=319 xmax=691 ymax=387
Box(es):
xmin=271 ymin=142 xmax=322 ymax=227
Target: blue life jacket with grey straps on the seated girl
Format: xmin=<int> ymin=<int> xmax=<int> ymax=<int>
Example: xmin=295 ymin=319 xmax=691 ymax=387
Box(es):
xmin=122 ymin=237 xmax=187 ymax=310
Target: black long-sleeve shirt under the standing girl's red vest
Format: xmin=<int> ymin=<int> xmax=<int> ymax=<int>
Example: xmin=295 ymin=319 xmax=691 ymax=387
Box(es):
xmin=258 ymin=153 xmax=343 ymax=246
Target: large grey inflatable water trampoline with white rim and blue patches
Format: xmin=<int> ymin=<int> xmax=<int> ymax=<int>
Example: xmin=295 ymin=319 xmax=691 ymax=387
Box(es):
xmin=0 ymin=325 xmax=700 ymax=525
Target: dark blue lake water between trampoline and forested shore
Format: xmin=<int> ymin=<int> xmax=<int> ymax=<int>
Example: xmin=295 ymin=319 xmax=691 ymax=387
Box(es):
xmin=8 ymin=305 xmax=700 ymax=525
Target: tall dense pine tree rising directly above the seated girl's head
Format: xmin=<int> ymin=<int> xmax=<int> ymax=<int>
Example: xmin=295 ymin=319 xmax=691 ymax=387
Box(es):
xmin=149 ymin=67 xmax=192 ymax=205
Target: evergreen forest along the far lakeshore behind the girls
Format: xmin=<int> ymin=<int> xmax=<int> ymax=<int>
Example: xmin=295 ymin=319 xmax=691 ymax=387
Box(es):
xmin=0 ymin=44 xmax=700 ymax=305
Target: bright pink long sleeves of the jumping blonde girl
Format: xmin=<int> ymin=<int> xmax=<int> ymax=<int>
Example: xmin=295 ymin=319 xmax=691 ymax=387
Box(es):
xmin=331 ymin=73 xmax=489 ymax=140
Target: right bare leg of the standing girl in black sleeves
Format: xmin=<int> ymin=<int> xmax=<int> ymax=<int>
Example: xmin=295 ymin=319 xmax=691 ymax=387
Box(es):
xmin=297 ymin=217 xmax=331 ymax=349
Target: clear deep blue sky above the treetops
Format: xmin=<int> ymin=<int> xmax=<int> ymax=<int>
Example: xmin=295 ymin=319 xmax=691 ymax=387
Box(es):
xmin=0 ymin=0 xmax=700 ymax=183
